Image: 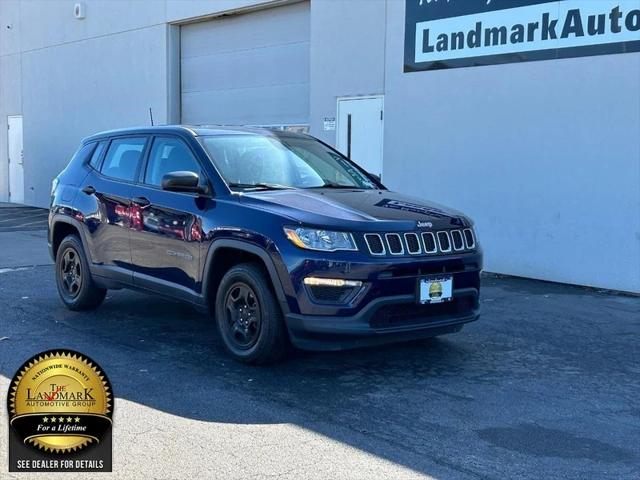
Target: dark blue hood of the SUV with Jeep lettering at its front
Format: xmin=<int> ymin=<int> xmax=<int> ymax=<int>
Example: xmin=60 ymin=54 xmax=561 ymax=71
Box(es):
xmin=242 ymin=188 xmax=469 ymax=230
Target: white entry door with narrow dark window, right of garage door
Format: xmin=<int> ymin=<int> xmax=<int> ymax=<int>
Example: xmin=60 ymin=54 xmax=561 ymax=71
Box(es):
xmin=337 ymin=96 xmax=384 ymax=177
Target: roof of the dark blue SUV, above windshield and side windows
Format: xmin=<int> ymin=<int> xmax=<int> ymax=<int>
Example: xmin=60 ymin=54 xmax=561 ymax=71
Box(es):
xmin=83 ymin=125 xmax=306 ymax=142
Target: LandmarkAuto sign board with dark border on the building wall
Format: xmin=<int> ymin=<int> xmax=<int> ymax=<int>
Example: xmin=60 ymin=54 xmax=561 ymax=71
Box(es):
xmin=404 ymin=0 xmax=640 ymax=72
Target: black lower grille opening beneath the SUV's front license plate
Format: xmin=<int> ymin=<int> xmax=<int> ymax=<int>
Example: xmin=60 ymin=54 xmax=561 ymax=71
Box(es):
xmin=369 ymin=295 xmax=477 ymax=328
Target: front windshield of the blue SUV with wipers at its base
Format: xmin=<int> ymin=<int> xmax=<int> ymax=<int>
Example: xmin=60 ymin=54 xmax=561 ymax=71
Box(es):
xmin=200 ymin=134 xmax=377 ymax=189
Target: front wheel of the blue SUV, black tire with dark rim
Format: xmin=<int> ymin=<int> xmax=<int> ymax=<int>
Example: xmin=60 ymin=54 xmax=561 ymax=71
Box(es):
xmin=215 ymin=263 xmax=288 ymax=365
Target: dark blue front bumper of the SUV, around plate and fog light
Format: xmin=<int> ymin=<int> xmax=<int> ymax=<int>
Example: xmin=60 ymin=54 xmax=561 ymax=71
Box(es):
xmin=281 ymin=249 xmax=483 ymax=350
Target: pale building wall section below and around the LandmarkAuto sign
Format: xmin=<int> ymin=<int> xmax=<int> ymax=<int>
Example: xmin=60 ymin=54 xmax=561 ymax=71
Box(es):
xmin=384 ymin=1 xmax=640 ymax=292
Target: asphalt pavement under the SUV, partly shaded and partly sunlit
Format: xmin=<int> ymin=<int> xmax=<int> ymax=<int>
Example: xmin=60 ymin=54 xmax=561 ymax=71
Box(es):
xmin=0 ymin=208 xmax=640 ymax=479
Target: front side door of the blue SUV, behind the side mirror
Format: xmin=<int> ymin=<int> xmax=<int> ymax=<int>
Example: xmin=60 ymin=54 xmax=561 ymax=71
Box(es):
xmin=131 ymin=136 xmax=209 ymax=296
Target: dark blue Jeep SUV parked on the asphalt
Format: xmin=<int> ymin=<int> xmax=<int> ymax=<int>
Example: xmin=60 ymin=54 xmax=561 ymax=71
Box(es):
xmin=49 ymin=126 xmax=482 ymax=363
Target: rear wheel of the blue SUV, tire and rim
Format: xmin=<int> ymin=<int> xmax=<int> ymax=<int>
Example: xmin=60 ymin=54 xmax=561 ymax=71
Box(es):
xmin=56 ymin=235 xmax=107 ymax=311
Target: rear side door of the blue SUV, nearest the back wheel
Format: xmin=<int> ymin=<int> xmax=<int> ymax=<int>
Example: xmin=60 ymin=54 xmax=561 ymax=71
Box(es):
xmin=77 ymin=135 xmax=148 ymax=282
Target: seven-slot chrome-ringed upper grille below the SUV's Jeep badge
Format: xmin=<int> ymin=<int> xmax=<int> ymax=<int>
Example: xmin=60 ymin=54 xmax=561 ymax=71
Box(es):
xmin=364 ymin=228 xmax=476 ymax=255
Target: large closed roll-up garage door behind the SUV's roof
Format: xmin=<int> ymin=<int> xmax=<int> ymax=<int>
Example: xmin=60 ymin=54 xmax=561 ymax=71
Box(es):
xmin=180 ymin=2 xmax=309 ymax=126
